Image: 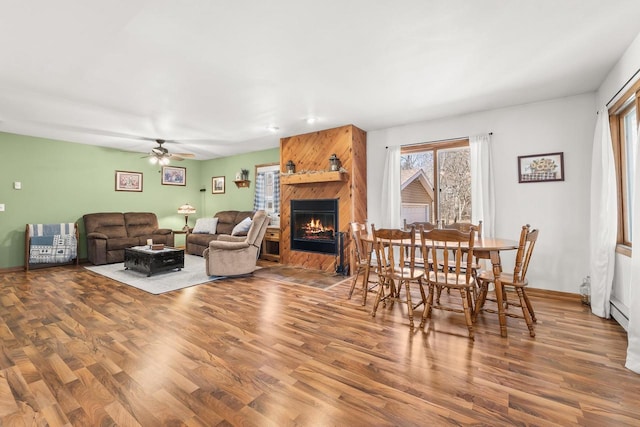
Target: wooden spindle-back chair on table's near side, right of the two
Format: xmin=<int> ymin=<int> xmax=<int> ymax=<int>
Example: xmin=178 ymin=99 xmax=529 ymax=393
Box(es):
xmin=420 ymin=227 xmax=476 ymax=339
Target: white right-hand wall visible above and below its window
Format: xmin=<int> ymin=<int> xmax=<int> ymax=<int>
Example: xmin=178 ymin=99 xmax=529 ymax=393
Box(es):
xmin=596 ymin=34 xmax=640 ymax=322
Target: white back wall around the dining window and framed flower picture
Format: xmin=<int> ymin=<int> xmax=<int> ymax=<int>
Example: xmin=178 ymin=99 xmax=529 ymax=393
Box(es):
xmin=367 ymin=93 xmax=596 ymax=293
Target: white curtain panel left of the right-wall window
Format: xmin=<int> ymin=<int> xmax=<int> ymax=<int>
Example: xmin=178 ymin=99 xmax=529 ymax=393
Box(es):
xmin=589 ymin=107 xmax=618 ymax=318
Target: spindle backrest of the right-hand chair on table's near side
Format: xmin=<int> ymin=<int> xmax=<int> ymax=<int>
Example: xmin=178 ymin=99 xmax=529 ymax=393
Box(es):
xmin=420 ymin=227 xmax=476 ymax=285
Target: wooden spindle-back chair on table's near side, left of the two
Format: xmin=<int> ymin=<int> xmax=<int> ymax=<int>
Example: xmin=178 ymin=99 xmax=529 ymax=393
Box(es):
xmin=371 ymin=224 xmax=426 ymax=328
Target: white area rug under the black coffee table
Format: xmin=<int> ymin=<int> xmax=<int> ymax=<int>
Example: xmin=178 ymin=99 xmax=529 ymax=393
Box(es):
xmin=85 ymin=254 xmax=225 ymax=295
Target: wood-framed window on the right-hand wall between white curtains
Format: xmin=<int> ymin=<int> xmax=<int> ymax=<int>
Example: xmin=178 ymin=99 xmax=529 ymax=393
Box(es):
xmin=609 ymin=83 xmax=640 ymax=247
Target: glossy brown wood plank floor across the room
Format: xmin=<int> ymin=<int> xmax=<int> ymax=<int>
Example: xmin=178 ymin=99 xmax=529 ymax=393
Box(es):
xmin=0 ymin=266 xmax=640 ymax=426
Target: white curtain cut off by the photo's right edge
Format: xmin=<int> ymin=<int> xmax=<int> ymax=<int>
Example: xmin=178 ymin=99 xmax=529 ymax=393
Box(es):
xmin=625 ymin=122 xmax=640 ymax=374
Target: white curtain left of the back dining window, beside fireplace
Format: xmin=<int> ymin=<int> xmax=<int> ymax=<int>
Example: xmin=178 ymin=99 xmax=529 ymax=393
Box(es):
xmin=376 ymin=146 xmax=402 ymax=228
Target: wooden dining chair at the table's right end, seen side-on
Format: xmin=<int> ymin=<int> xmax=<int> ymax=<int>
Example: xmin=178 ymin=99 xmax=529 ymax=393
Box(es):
xmin=474 ymin=224 xmax=539 ymax=337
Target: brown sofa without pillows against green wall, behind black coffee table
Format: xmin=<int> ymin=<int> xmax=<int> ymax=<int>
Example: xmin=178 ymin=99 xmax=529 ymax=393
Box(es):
xmin=82 ymin=212 xmax=173 ymax=265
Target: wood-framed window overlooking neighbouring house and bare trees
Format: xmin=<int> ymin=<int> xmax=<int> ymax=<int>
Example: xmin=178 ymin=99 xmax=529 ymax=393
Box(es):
xmin=400 ymin=139 xmax=471 ymax=224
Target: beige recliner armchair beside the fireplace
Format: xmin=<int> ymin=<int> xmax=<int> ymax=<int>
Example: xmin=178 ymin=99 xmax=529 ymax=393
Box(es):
xmin=202 ymin=211 xmax=269 ymax=276
